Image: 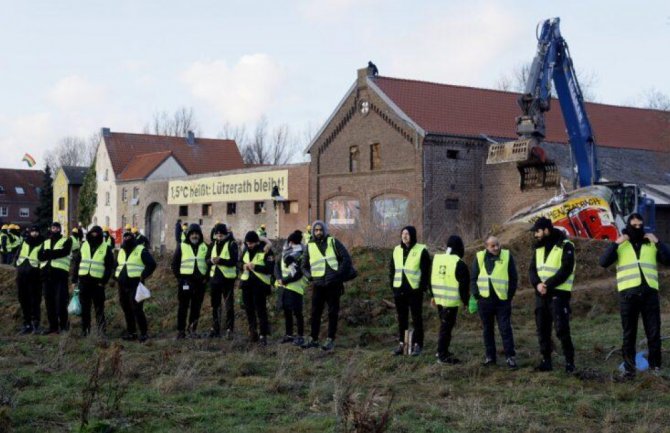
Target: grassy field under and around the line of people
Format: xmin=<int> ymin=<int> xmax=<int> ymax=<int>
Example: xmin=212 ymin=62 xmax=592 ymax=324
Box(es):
xmin=0 ymin=244 xmax=670 ymax=433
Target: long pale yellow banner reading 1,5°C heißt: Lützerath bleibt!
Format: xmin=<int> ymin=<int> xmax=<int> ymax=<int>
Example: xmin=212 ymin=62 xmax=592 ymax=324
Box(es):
xmin=168 ymin=170 xmax=288 ymax=205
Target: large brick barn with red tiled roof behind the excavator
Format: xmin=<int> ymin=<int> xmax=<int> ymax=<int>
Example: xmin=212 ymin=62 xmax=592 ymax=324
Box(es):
xmin=307 ymin=69 xmax=670 ymax=244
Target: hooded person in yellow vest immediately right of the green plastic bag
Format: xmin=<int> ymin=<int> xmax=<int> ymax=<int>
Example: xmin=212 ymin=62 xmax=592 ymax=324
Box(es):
xmin=72 ymin=226 xmax=115 ymax=337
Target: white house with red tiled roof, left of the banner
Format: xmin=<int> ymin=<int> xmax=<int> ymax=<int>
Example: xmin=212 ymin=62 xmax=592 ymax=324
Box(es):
xmin=93 ymin=128 xmax=245 ymax=246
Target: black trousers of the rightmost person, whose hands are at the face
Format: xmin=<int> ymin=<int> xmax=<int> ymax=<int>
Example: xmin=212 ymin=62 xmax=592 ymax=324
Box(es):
xmin=619 ymin=289 xmax=661 ymax=372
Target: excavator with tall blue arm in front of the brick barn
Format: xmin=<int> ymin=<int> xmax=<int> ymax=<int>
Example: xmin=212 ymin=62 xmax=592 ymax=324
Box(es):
xmin=486 ymin=18 xmax=655 ymax=235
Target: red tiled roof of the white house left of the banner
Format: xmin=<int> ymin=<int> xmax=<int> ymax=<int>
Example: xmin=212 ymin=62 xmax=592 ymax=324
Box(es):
xmin=103 ymin=132 xmax=244 ymax=177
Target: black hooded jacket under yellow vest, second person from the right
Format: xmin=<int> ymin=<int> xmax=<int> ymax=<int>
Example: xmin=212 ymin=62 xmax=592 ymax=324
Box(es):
xmin=528 ymin=228 xmax=575 ymax=298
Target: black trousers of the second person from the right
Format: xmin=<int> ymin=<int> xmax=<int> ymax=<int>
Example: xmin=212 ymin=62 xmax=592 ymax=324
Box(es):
xmin=535 ymin=295 xmax=575 ymax=364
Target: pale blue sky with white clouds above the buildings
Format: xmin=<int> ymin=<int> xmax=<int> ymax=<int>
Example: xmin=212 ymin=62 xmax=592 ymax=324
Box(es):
xmin=0 ymin=0 xmax=670 ymax=168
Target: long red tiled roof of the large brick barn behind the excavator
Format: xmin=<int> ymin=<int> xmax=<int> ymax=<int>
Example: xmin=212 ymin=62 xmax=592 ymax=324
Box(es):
xmin=373 ymin=77 xmax=670 ymax=152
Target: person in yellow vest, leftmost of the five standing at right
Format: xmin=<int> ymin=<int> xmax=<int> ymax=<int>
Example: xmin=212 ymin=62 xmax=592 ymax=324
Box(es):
xmin=389 ymin=226 xmax=430 ymax=356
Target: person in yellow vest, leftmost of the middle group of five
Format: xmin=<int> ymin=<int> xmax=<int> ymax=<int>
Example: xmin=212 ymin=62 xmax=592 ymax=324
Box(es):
xmin=172 ymin=224 xmax=209 ymax=340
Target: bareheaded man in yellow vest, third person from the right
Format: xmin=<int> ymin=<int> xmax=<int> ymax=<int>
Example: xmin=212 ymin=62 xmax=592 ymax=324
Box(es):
xmin=470 ymin=236 xmax=518 ymax=370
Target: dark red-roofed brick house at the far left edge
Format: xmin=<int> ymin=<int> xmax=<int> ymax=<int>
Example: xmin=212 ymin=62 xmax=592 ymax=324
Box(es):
xmin=0 ymin=168 xmax=44 ymax=228
